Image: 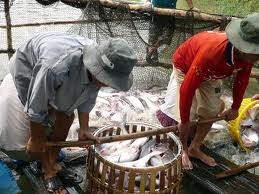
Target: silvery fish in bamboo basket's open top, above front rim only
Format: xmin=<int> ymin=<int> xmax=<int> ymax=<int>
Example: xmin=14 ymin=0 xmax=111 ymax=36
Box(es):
xmin=96 ymin=137 xmax=174 ymax=168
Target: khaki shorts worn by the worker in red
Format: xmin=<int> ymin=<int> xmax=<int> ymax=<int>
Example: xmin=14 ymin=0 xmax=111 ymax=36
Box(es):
xmin=161 ymin=68 xmax=222 ymax=121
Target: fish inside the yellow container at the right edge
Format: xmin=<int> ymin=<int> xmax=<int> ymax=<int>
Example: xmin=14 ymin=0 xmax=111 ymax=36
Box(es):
xmin=240 ymin=103 xmax=259 ymax=148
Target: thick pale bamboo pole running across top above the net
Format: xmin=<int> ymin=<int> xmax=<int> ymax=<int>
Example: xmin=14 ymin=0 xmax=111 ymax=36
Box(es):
xmin=62 ymin=0 xmax=238 ymax=23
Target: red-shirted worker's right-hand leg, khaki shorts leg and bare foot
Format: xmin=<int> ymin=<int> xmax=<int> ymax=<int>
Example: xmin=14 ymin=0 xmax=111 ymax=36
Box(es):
xmin=188 ymin=80 xmax=222 ymax=166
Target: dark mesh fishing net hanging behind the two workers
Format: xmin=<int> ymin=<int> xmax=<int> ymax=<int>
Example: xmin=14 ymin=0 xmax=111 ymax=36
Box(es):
xmin=0 ymin=0 xmax=228 ymax=89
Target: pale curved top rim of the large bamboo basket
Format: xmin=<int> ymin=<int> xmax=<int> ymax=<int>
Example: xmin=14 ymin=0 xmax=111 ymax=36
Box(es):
xmin=90 ymin=122 xmax=183 ymax=172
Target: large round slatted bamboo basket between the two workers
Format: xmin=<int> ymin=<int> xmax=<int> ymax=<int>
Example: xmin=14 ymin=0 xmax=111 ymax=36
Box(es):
xmin=86 ymin=123 xmax=182 ymax=194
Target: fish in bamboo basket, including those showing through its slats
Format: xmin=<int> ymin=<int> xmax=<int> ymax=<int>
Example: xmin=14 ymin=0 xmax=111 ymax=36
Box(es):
xmin=93 ymin=137 xmax=175 ymax=192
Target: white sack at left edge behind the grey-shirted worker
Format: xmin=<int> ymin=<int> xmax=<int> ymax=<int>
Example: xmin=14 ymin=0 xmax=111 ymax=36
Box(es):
xmin=0 ymin=74 xmax=30 ymax=151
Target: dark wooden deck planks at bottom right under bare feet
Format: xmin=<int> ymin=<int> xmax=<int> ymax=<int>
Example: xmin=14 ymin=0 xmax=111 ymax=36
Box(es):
xmin=185 ymin=148 xmax=259 ymax=194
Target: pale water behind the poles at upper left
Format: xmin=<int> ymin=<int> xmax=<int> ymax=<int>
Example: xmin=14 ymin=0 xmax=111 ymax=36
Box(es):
xmin=0 ymin=0 xmax=82 ymax=80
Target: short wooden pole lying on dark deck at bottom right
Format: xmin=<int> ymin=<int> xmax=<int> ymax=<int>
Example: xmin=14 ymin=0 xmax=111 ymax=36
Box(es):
xmin=216 ymin=162 xmax=259 ymax=179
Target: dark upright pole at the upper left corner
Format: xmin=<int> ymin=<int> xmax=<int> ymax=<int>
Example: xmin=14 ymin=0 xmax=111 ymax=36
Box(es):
xmin=4 ymin=0 xmax=13 ymax=59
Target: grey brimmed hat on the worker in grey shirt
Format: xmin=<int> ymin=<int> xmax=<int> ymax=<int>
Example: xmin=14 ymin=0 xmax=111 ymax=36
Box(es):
xmin=83 ymin=38 xmax=137 ymax=91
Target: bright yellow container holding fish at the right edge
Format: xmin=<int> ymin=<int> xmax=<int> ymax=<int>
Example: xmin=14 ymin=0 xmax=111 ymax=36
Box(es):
xmin=228 ymin=98 xmax=259 ymax=151
